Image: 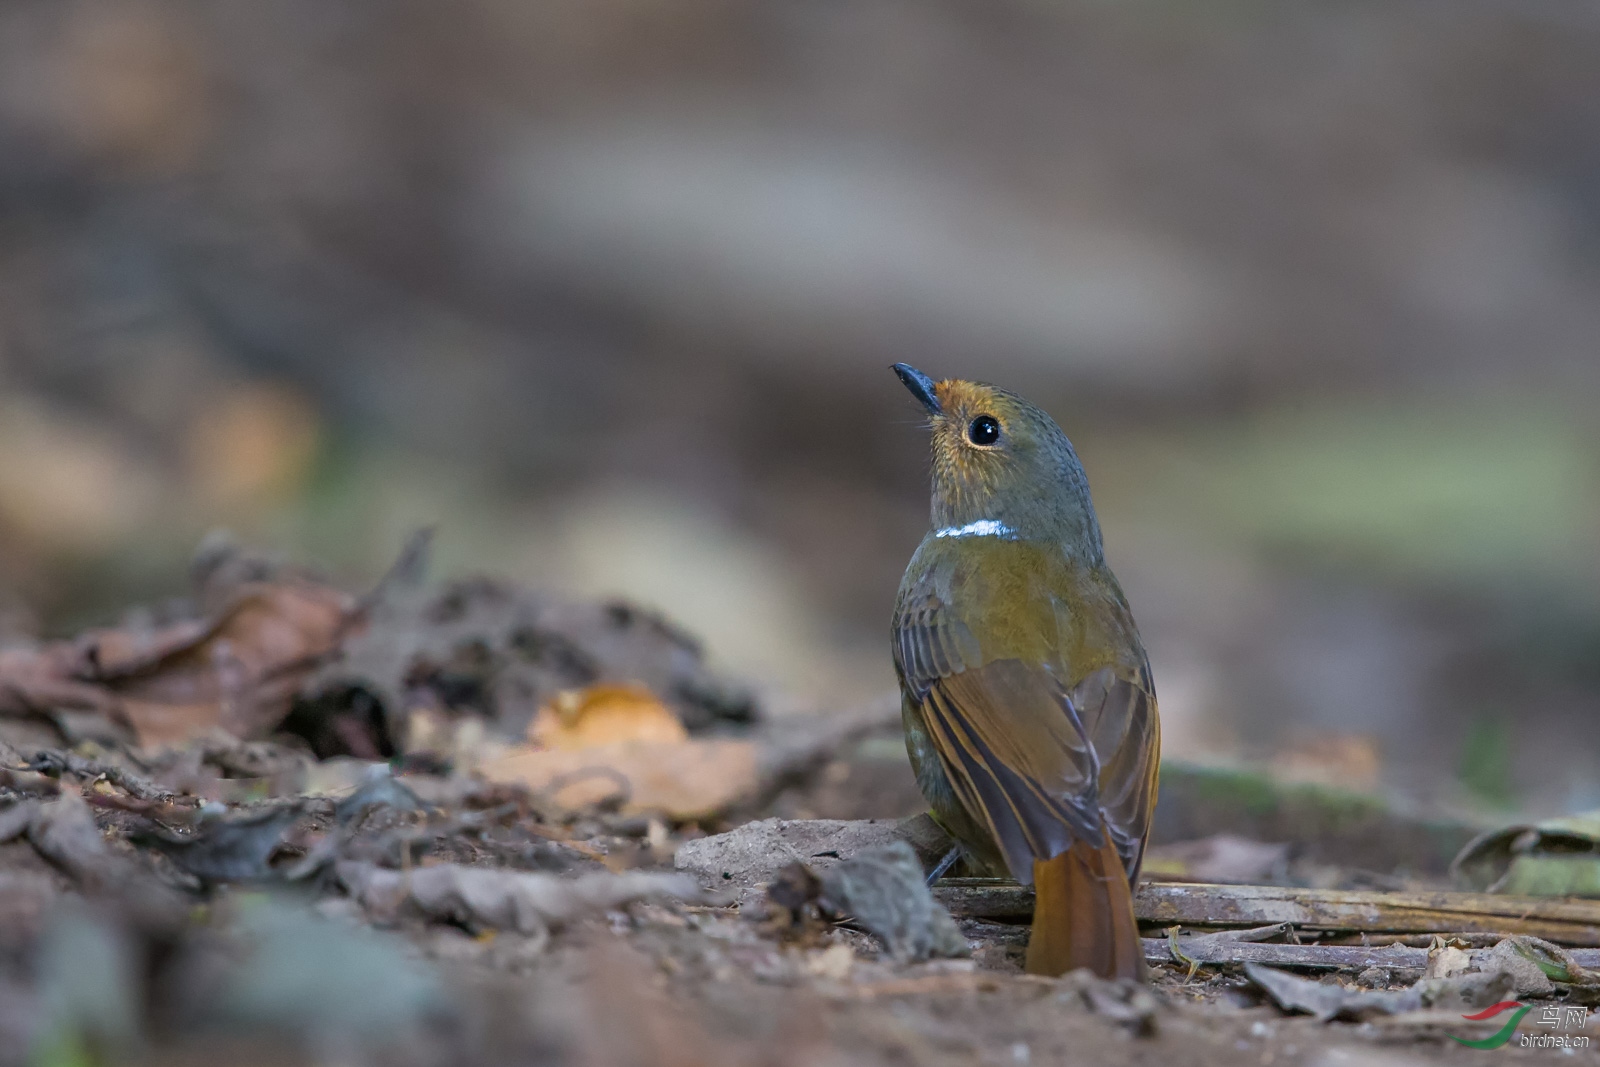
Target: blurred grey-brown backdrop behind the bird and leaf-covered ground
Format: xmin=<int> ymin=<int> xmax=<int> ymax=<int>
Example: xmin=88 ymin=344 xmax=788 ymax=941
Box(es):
xmin=0 ymin=0 xmax=1600 ymax=813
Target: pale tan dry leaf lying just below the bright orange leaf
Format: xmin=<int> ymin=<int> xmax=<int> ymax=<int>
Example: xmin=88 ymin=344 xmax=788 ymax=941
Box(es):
xmin=478 ymin=739 xmax=760 ymax=819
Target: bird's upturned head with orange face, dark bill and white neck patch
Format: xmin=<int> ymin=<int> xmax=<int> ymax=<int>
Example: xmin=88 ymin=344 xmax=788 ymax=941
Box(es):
xmin=894 ymin=363 xmax=1101 ymax=561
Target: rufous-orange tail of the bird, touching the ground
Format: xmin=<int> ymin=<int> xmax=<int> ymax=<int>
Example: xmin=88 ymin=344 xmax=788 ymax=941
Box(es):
xmin=1027 ymin=835 xmax=1144 ymax=981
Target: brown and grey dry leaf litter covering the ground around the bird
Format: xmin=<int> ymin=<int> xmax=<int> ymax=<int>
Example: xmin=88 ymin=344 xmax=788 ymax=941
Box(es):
xmin=0 ymin=534 xmax=1595 ymax=1067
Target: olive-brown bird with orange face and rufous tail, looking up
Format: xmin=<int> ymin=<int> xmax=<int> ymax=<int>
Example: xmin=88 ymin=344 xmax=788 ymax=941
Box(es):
xmin=893 ymin=363 xmax=1162 ymax=981
